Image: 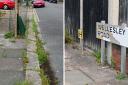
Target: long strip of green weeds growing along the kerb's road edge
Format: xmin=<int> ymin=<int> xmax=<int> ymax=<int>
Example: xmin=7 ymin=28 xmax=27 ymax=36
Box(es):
xmin=32 ymin=18 xmax=51 ymax=85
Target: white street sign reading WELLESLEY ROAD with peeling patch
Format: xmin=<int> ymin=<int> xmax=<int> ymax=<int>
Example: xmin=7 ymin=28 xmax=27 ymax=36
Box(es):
xmin=96 ymin=22 xmax=128 ymax=47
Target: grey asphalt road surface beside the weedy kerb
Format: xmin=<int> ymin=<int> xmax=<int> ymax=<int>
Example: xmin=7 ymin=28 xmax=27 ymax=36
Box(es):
xmin=36 ymin=2 xmax=63 ymax=85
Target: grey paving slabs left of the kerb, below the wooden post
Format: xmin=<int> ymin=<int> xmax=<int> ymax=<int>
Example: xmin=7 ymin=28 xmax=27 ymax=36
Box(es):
xmin=0 ymin=34 xmax=25 ymax=85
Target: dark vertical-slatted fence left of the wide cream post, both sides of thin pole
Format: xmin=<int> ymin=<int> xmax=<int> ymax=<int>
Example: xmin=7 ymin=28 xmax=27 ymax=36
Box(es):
xmin=65 ymin=0 xmax=108 ymax=50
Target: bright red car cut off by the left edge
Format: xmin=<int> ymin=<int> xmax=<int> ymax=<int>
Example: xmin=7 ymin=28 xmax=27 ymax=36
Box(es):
xmin=0 ymin=0 xmax=15 ymax=10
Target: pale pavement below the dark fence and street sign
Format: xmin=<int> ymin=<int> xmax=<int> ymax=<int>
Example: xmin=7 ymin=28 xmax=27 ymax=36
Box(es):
xmin=65 ymin=45 xmax=128 ymax=85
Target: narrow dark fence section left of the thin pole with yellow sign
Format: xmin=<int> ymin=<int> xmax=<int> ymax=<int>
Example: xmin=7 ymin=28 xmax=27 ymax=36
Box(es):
xmin=65 ymin=0 xmax=80 ymax=42
